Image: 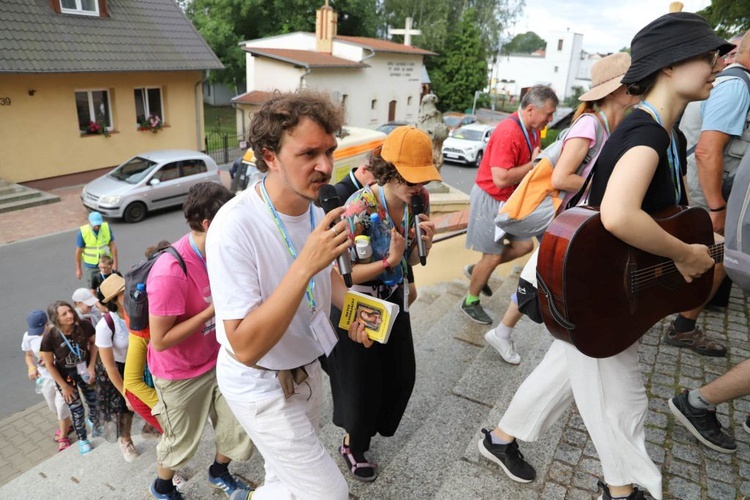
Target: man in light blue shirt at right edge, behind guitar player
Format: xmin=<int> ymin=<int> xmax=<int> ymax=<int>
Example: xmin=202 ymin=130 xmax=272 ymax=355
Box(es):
xmin=664 ymin=33 xmax=750 ymax=356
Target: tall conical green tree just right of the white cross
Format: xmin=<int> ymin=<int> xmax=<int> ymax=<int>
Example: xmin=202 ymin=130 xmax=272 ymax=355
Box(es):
xmin=430 ymin=9 xmax=487 ymax=111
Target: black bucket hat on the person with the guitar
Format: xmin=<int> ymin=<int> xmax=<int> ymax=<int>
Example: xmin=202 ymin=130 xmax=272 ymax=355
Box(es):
xmin=622 ymin=12 xmax=734 ymax=84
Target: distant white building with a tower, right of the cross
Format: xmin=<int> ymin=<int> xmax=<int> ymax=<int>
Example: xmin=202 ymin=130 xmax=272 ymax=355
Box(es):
xmin=492 ymin=31 xmax=601 ymax=100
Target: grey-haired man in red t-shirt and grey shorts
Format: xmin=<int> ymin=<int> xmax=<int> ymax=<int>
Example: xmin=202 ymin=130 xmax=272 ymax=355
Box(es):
xmin=461 ymin=85 xmax=558 ymax=334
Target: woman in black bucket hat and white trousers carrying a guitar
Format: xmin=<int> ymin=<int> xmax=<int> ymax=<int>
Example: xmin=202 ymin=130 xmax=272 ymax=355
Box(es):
xmin=479 ymin=12 xmax=733 ymax=500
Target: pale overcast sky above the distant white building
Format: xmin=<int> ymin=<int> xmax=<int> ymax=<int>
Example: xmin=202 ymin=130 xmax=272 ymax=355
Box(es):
xmin=510 ymin=0 xmax=711 ymax=52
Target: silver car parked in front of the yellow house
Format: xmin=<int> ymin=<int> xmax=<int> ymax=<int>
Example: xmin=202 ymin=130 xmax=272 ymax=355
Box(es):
xmin=81 ymin=149 xmax=221 ymax=222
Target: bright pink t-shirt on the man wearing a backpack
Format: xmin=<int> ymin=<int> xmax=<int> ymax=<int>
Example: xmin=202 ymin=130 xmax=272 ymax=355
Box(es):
xmin=146 ymin=234 xmax=219 ymax=380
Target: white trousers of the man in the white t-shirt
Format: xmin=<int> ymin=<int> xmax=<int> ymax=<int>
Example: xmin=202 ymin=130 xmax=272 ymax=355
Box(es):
xmin=225 ymin=361 xmax=349 ymax=500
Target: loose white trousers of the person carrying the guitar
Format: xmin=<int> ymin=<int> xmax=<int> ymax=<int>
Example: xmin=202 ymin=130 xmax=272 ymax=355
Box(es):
xmin=498 ymin=340 xmax=662 ymax=500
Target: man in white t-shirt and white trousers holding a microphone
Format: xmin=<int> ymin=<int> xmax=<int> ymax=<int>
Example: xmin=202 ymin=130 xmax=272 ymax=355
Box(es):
xmin=206 ymin=91 xmax=371 ymax=500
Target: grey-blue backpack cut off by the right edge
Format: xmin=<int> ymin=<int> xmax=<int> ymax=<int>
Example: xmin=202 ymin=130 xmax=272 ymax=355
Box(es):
xmin=724 ymin=151 xmax=750 ymax=292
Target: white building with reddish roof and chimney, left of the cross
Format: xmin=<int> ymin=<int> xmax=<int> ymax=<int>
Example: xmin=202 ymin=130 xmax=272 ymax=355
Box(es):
xmin=233 ymin=6 xmax=436 ymax=134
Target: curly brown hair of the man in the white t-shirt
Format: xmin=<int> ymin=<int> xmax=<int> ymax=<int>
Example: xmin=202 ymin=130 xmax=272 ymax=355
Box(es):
xmin=253 ymin=89 xmax=344 ymax=173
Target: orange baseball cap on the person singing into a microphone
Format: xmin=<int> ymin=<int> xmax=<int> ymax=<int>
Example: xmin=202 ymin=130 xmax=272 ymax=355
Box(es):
xmin=380 ymin=125 xmax=442 ymax=184
